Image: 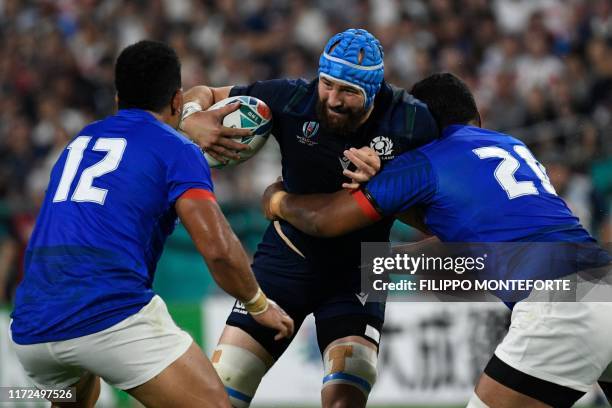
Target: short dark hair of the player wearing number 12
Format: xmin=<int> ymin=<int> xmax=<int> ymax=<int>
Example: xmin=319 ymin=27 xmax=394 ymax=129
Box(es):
xmin=115 ymin=40 xmax=181 ymax=112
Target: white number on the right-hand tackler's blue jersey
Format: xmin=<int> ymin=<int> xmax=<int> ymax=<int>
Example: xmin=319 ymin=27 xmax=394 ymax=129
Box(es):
xmin=472 ymin=145 xmax=557 ymax=200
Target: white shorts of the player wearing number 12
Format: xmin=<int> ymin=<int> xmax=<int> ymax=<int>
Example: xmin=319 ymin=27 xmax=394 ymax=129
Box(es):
xmin=11 ymin=295 xmax=193 ymax=390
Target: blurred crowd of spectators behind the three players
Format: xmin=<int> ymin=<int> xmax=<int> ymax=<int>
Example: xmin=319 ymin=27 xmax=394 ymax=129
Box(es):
xmin=0 ymin=0 xmax=612 ymax=300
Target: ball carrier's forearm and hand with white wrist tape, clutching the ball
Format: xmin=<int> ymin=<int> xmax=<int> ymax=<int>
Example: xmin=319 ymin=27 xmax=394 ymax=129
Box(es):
xmin=180 ymin=85 xmax=251 ymax=162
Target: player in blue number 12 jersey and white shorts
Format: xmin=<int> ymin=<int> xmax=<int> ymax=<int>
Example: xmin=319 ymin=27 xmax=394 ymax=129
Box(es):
xmin=10 ymin=41 xmax=293 ymax=408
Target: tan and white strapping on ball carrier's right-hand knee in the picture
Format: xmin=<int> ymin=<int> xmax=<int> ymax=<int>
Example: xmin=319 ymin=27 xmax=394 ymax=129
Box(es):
xmin=323 ymin=342 xmax=378 ymax=397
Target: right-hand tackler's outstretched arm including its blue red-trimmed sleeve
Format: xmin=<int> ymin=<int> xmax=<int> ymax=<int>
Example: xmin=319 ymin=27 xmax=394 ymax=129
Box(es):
xmin=262 ymin=148 xmax=437 ymax=237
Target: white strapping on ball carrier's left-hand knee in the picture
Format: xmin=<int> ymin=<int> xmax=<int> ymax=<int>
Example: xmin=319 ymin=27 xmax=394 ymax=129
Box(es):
xmin=211 ymin=344 xmax=268 ymax=408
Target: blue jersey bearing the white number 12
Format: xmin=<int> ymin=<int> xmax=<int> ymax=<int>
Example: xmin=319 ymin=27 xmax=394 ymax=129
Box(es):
xmin=11 ymin=109 xmax=213 ymax=344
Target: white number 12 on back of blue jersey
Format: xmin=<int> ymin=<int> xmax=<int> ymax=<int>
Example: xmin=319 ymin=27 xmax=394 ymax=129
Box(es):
xmin=53 ymin=136 xmax=127 ymax=205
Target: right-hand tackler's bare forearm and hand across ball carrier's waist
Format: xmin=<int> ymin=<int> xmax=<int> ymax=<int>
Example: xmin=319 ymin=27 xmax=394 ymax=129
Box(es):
xmin=262 ymin=181 xmax=381 ymax=237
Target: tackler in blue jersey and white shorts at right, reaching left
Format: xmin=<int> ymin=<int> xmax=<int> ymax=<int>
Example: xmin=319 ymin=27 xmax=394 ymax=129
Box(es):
xmin=263 ymin=74 xmax=612 ymax=408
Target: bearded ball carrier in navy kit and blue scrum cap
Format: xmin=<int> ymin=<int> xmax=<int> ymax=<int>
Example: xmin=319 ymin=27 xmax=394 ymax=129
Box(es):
xmin=182 ymin=29 xmax=439 ymax=407
